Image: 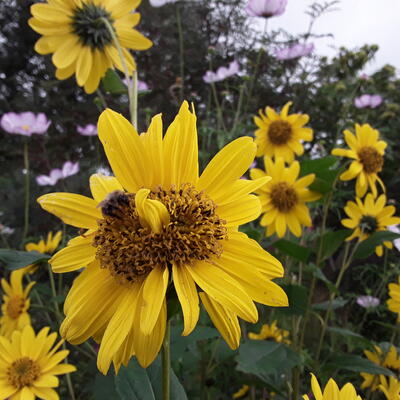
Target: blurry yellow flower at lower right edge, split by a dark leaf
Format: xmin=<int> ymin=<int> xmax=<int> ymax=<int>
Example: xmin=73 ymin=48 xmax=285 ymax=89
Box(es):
xmin=360 ymin=346 xmax=400 ymax=390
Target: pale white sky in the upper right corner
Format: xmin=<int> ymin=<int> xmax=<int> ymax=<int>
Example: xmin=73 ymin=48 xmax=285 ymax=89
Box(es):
xmin=268 ymin=0 xmax=400 ymax=73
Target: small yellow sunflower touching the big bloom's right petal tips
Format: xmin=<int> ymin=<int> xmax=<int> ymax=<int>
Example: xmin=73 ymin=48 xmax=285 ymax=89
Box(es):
xmin=250 ymin=157 xmax=321 ymax=237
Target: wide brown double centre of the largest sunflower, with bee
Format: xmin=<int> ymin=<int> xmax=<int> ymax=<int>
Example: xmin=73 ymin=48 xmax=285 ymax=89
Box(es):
xmin=93 ymin=184 xmax=227 ymax=283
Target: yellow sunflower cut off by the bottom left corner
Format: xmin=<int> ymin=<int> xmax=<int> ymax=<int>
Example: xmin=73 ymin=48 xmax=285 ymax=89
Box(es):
xmin=0 ymin=325 xmax=76 ymax=400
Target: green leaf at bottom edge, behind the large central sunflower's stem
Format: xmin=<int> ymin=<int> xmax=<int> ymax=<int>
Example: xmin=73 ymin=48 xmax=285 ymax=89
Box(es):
xmin=115 ymin=357 xmax=187 ymax=400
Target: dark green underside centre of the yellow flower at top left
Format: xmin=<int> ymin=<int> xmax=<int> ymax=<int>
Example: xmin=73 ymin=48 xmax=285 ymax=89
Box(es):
xmin=72 ymin=3 xmax=113 ymax=50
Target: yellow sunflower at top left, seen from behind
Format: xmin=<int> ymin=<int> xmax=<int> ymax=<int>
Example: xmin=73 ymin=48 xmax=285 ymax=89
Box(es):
xmin=29 ymin=0 xmax=152 ymax=93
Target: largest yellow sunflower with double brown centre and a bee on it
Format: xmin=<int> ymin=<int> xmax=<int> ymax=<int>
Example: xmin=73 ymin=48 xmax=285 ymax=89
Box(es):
xmin=38 ymin=102 xmax=287 ymax=373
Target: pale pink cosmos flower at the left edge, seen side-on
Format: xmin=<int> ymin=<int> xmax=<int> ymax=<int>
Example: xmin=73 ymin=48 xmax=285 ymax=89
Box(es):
xmin=0 ymin=111 xmax=51 ymax=136
